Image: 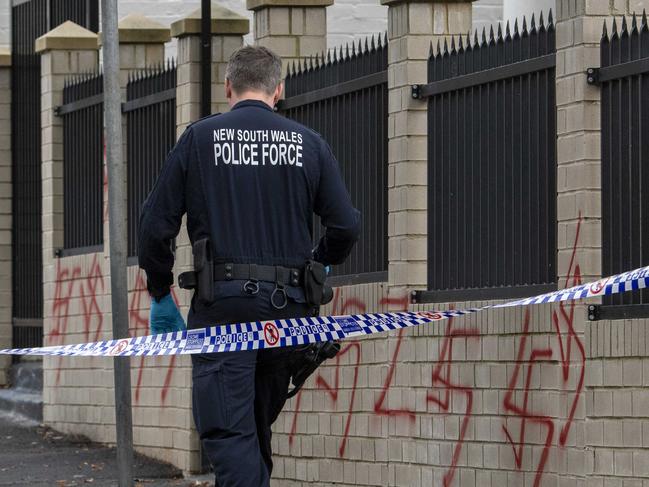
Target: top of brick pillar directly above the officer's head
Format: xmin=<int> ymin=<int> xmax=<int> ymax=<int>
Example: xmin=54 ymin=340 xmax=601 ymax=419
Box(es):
xmin=246 ymin=0 xmax=334 ymax=69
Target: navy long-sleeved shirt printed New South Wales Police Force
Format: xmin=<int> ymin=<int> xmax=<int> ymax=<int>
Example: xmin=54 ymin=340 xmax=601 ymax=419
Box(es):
xmin=138 ymin=100 xmax=360 ymax=294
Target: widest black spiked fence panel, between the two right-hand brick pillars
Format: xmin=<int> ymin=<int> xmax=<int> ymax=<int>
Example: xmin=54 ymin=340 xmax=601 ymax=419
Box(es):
xmin=413 ymin=14 xmax=557 ymax=301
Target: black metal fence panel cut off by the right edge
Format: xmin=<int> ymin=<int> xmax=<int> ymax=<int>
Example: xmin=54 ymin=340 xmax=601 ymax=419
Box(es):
xmin=589 ymin=15 xmax=649 ymax=318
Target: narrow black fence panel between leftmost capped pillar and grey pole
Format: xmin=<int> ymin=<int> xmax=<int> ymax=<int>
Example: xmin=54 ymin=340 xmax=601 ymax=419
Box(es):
xmin=57 ymin=74 xmax=104 ymax=255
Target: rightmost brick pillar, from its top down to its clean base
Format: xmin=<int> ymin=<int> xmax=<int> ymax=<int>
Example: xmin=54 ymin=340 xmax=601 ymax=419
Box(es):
xmin=557 ymin=0 xmax=649 ymax=486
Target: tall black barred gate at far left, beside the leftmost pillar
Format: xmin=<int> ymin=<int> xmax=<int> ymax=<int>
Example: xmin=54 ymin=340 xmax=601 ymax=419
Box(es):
xmin=11 ymin=0 xmax=99 ymax=347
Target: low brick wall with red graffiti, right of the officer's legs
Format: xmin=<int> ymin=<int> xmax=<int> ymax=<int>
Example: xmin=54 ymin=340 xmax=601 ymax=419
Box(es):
xmin=274 ymin=292 xmax=589 ymax=487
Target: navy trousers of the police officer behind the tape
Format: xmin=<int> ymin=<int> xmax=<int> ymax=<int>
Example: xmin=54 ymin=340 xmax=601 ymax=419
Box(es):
xmin=188 ymin=283 xmax=313 ymax=487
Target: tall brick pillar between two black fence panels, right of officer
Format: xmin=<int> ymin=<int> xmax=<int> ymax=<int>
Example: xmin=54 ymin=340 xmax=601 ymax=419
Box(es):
xmin=381 ymin=0 xmax=472 ymax=302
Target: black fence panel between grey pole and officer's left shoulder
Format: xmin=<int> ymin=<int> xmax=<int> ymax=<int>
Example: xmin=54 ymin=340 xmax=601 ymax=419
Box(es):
xmin=122 ymin=63 xmax=176 ymax=257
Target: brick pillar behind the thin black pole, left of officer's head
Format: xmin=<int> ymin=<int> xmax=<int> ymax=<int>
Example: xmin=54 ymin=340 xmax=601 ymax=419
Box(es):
xmin=171 ymin=3 xmax=250 ymax=132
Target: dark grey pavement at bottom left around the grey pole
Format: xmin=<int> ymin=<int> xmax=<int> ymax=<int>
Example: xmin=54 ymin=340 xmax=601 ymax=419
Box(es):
xmin=0 ymin=414 xmax=213 ymax=487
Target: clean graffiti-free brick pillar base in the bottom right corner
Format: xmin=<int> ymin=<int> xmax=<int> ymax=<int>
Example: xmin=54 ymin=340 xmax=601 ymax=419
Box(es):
xmin=585 ymin=320 xmax=649 ymax=485
